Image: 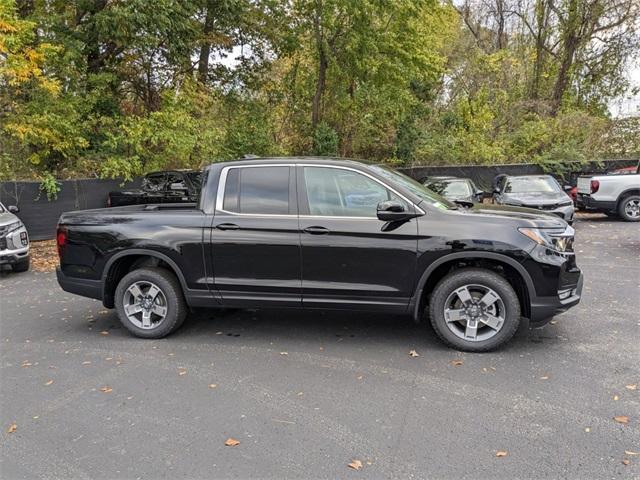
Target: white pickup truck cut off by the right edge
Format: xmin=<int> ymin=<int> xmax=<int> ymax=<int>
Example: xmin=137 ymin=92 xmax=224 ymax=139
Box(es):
xmin=577 ymin=163 xmax=640 ymax=222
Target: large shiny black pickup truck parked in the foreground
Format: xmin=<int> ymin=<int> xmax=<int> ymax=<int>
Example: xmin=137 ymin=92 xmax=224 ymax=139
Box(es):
xmin=57 ymin=158 xmax=582 ymax=351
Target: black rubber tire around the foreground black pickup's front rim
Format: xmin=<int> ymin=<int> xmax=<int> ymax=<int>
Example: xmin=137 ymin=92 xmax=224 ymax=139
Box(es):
xmin=429 ymin=268 xmax=520 ymax=352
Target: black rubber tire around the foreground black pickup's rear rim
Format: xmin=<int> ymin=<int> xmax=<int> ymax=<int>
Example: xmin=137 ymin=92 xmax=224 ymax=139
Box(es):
xmin=115 ymin=267 xmax=188 ymax=338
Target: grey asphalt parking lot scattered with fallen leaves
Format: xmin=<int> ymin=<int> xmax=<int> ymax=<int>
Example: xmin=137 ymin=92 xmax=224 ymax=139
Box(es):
xmin=0 ymin=215 xmax=640 ymax=479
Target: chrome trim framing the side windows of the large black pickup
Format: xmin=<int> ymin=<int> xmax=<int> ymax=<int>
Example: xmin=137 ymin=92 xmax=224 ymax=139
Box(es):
xmin=215 ymin=163 xmax=426 ymax=220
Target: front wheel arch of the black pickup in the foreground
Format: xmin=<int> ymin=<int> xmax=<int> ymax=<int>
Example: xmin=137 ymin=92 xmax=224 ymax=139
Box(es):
xmin=412 ymin=252 xmax=536 ymax=321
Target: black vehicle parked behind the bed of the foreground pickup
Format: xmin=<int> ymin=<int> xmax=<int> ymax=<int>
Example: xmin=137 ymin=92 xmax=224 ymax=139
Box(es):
xmin=107 ymin=170 xmax=202 ymax=207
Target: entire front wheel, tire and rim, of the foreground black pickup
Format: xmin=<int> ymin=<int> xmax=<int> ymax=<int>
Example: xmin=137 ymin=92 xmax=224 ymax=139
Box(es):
xmin=429 ymin=268 xmax=520 ymax=352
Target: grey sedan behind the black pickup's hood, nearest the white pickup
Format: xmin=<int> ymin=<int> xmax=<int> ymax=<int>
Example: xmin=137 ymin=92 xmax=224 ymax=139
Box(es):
xmin=493 ymin=175 xmax=575 ymax=224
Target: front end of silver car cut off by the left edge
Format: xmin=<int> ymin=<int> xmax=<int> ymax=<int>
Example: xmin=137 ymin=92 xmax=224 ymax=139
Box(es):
xmin=0 ymin=203 xmax=29 ymax=272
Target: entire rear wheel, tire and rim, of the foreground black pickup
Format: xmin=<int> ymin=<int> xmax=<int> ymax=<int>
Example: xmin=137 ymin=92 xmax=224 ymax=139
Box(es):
xmin=115 ymin=267 xmax=187 ymax=338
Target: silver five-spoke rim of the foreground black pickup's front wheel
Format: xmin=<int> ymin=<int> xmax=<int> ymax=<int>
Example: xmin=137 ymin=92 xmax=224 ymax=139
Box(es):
xmin=444 ymin=285 xmax=506 ymax=342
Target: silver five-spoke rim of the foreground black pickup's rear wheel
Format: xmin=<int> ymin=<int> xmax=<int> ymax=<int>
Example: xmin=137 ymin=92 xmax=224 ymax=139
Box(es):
xmin=122 ymin=280 xmax=167 ymax=330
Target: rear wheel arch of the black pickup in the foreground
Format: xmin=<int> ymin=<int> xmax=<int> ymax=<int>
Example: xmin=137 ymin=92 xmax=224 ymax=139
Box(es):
xmin=102 ymin=248 xmax=187 ymax=308
